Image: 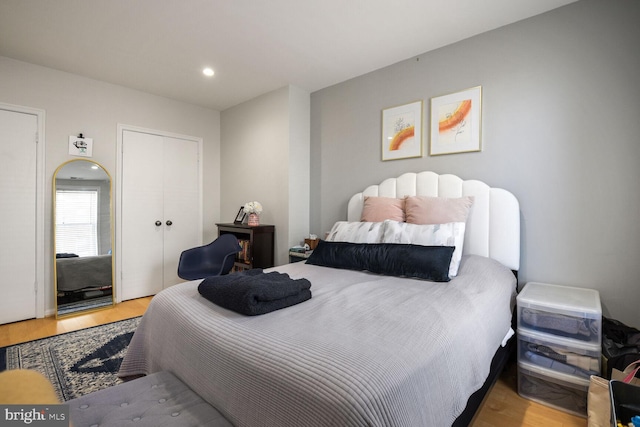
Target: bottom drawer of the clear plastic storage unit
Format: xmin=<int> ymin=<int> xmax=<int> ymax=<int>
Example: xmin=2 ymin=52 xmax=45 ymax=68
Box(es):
xmin=518 ymin=362 xmax=589 ymax=417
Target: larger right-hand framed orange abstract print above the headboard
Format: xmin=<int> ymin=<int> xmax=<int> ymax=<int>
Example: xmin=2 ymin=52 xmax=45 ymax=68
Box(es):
xmin=429 ymin=86 xmax=482 ymax=156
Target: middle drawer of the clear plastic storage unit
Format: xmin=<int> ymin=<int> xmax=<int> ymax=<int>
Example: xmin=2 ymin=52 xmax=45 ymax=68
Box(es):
xmin=518 ymin=329 xmax=601 ymax=380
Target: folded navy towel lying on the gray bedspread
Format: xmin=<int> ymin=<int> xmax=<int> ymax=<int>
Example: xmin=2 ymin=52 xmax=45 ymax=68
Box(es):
xmin=198 ymin=268 xmax=311 ymax=316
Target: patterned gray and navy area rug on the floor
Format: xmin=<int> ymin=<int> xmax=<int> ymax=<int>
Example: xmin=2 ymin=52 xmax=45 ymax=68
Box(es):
xmin=0 ymin=317 xmax=140 ymax=401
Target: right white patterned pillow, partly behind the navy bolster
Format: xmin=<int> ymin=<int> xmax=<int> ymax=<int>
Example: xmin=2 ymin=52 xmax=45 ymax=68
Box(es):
xmin=382 ymin=220 xmax=466 ymax=278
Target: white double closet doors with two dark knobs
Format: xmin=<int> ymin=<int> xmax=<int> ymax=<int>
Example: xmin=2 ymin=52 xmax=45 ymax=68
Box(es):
xmin=121 ymin=130 xmax=202 ymax=300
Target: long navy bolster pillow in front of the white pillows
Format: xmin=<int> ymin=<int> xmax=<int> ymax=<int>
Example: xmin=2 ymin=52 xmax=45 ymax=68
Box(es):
xmin=307 ymin=240 xmax=455 ymax=282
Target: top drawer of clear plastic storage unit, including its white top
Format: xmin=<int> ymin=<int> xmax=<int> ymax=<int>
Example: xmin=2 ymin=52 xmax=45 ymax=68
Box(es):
xmin=517 ymin=282 xmax=602 ymax=347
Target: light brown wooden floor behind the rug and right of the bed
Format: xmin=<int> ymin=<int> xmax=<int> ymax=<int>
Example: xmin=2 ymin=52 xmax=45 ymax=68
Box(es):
xmin=0 ymin=297 xmax=587 ymax=427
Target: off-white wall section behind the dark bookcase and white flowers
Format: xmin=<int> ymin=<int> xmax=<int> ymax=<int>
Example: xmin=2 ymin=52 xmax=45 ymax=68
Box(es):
xmin=221 ymin=86 xmax=310 ymax=265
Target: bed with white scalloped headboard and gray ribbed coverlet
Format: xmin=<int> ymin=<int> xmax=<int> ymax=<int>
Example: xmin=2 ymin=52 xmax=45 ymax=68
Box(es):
xmin=119 ymin=172 xmax=520 ymax=426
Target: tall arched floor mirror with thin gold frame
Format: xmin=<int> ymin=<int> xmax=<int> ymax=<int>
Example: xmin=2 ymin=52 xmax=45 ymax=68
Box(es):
xmin=53 ymin=159 xmax=114 ymax=317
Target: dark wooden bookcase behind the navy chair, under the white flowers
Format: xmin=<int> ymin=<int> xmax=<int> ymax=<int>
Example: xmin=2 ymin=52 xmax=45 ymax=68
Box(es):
xmin=216 ymin=223 xmax=275 ymax=271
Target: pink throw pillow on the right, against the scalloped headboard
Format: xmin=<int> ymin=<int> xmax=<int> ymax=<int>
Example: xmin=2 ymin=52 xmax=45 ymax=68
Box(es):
xmin=405 ymin=196 xmax=473 ymax=224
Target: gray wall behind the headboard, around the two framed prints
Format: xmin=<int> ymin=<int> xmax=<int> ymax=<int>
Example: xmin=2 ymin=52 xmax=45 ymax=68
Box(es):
xmin=311 ymin=0 xmax=640 ymax=327
